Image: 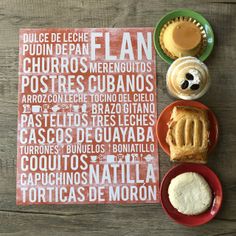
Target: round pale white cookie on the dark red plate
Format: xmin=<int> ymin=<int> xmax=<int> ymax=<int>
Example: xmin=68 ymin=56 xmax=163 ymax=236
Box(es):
xmin=168 ymin=172 xmax=212 ymax=215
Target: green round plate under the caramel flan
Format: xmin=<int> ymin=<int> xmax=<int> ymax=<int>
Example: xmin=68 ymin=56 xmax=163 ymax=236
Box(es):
xmin=154 ymin=9 xmax=214 ymax=64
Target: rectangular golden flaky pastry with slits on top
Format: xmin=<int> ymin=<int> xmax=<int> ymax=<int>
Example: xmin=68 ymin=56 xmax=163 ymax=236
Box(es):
xmin=166 ymin=106 xmax=209 ymax=163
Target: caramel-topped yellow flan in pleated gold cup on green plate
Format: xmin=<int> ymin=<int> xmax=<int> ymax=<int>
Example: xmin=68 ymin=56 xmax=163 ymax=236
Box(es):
xmin=160 ymin=18 xmax=204 ymax=59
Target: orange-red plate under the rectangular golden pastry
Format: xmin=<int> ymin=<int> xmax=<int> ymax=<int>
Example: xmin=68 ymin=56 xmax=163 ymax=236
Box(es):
xmin=156 ymin=100 xmax=218 ymax=155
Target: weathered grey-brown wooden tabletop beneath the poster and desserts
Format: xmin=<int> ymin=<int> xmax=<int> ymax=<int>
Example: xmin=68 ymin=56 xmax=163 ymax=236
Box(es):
xmin=0 ymin=0 xmax=236 ymax=236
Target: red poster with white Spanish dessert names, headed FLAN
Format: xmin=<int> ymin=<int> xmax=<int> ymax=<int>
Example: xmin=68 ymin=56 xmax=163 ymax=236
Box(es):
xmin=16 ymin=28 xmax=159 ymax=205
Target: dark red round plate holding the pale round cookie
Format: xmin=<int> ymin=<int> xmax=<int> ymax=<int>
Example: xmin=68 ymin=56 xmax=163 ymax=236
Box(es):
xmin=160 ymin=164 xmax=223 ymax=226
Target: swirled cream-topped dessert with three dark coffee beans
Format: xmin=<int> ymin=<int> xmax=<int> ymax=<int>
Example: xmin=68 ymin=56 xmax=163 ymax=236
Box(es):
xmin=166 ymin=56 xmax=211 ymax=100
